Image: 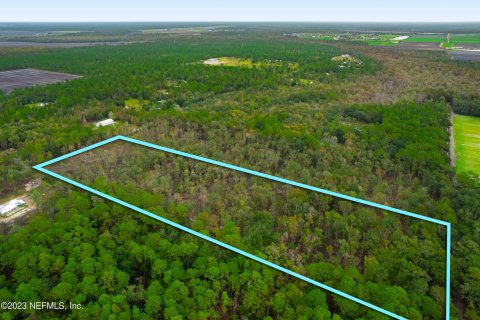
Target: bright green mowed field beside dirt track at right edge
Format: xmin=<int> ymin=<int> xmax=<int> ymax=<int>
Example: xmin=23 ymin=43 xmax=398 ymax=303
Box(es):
xmin=453 ymin=114 xmax=480 ymax=175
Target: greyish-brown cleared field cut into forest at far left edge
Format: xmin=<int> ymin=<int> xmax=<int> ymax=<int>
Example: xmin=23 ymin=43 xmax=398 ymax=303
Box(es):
xmin=0 ymin=69 xmax=80 ymax=94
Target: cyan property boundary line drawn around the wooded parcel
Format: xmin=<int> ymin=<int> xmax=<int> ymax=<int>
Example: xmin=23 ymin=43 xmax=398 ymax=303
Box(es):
xmin=33 ymin=136 xmax=451 ymax=320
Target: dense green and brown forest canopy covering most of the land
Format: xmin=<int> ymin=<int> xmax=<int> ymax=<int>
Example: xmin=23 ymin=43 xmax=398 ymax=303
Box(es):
xmin=0 ymin=30 xmax=480 ymax=320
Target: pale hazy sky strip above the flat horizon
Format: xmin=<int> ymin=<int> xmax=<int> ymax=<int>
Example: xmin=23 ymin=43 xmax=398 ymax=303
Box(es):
xmin=0 ymin=0 xmax=480 ymax=22
